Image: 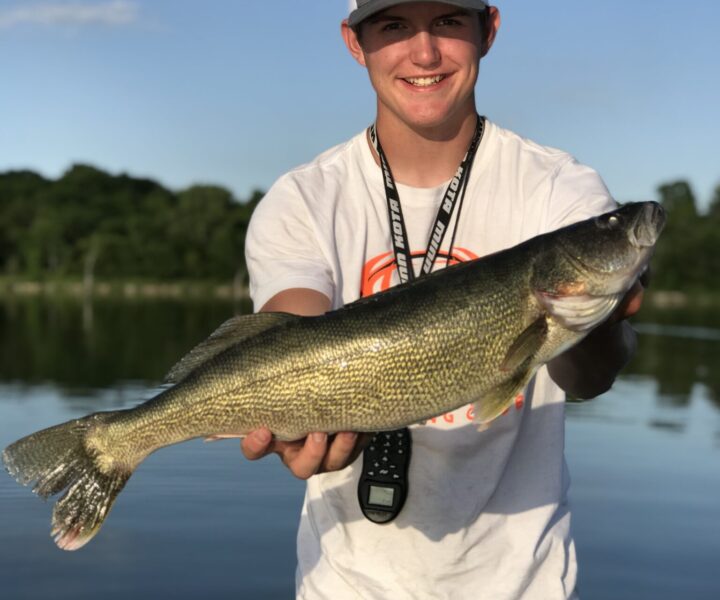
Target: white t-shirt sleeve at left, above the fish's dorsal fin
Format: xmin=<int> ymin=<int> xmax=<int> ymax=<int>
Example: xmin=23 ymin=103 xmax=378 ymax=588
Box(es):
xmin=245 ymin=180 xmax=334 ymax=310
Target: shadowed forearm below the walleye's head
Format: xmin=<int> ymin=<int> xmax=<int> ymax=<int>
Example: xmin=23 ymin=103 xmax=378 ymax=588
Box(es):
xmin=548 ymin=320 xmax=637 ymax=400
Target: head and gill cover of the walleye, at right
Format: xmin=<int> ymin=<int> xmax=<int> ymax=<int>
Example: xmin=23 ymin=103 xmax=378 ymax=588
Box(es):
xmin=532 ymin=202 xmax=665 ymax=331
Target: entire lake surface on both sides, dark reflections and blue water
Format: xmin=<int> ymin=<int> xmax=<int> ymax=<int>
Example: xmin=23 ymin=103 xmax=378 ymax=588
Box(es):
xmin=0 ymin=299 xmax=720 ymax=600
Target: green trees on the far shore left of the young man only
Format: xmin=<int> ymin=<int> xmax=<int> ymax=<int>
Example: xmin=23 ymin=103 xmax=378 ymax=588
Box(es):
xmin=0 ymin=165 xmax=262 ymax=281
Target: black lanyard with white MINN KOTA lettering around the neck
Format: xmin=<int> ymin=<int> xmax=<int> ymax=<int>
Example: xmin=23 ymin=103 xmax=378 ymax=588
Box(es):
xmin=369 ymin=115 xmax=485 ymax=283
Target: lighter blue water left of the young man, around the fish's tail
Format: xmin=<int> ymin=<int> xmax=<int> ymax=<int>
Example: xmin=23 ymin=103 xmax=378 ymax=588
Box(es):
xmin=0 ymin=384 xmax=304 ymax=600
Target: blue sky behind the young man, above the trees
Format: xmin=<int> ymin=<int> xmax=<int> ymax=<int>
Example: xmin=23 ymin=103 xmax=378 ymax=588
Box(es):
xmin=0 ymin=0 xmax=720 ymax=208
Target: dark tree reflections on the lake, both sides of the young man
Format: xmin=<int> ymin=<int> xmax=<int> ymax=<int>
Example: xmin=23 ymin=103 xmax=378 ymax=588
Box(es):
xmin=0 ymin=298 xmax=720 ymax=412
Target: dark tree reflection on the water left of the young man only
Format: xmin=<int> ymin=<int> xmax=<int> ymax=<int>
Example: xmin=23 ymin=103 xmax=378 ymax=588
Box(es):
xmin=0 ymin=298 xmax=249 ymax=392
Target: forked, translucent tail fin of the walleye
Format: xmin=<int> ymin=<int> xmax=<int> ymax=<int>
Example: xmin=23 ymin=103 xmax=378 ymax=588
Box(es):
xmin=2 ymin=412 xmax=132 ymax=550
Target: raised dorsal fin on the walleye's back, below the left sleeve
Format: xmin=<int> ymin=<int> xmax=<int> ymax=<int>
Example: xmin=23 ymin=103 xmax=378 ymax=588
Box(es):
xmin=165 ymin=312 xmax=298 ymax=383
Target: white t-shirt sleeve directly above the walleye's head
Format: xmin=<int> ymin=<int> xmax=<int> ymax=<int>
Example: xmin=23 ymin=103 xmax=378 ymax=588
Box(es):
xmin=547 ymin=157 xmax=618 ymax=231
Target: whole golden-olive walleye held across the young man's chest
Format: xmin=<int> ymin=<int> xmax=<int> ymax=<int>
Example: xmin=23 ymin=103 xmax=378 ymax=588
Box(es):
xmin=2 ymin=202 xmax=665 ymax=550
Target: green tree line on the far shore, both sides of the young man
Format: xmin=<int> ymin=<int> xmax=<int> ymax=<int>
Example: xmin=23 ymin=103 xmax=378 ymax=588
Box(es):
xmin=0 ymin=165 xmax=720 ymax=292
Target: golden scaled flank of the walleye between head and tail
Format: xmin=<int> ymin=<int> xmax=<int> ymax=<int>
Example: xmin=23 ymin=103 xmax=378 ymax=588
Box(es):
xmin=102 ymin=244 xmax=540 ymax=453
